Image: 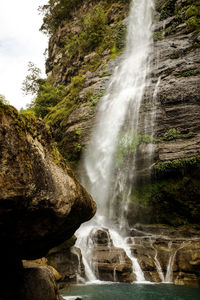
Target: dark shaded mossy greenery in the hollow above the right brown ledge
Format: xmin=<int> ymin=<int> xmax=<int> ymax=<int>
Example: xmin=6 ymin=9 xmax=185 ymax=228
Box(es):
xmin=131 ymin=171 xmax=200 ymax=225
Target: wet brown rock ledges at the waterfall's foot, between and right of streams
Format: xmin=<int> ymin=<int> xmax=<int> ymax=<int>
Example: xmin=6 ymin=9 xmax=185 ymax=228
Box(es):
xmin=61 ymin=225 xmax=200 ymax=287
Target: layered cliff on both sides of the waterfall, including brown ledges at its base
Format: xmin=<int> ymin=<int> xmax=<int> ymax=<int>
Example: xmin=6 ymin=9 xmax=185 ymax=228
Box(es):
xmin=34 ymin=0 xmax=200 ymax=286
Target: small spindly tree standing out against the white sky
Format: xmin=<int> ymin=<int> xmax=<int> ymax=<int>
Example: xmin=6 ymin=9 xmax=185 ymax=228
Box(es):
xmin=22 ymin=61 xmax=44 ymax=95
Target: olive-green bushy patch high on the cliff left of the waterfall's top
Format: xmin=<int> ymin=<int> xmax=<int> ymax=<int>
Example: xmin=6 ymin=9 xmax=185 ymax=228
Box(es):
xmin=62 ymin=1 xmax=126 ymax=67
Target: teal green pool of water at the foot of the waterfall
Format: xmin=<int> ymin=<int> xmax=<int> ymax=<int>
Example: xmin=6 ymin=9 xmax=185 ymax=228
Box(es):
xmin=61 ymin=284 xmax=200 ymax=300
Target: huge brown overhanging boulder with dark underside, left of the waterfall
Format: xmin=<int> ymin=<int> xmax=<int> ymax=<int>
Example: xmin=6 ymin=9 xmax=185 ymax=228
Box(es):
xmin=0 ymin=106 xmax=96 ymax=300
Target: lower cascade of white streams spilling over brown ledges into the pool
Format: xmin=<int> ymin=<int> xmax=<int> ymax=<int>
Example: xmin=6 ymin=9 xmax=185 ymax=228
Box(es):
xmin=76 ymin=224 xmax=200 ymax=284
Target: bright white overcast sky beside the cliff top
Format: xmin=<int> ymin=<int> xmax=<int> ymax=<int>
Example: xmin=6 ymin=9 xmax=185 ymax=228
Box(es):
xmin=0 ymin=0 xmax=47 ymax=109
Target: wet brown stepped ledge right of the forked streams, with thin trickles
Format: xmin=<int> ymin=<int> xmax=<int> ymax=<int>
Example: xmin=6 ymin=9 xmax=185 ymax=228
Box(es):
xmin=128 ymin=225 xmax=200 ymax=287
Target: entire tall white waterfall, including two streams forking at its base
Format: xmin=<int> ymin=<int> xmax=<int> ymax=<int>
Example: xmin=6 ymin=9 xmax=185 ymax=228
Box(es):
xmin=76 ymin=0 xmax=155 ymax=281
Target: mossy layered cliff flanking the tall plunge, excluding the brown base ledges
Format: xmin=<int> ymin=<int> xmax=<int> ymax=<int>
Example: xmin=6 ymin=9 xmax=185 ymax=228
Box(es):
xmin=45 ymin=0 xmax=200 ymax=224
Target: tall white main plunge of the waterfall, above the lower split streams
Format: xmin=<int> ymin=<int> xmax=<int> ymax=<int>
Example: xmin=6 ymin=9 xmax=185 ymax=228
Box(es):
xmin=82 ymin=0 xmax=153 ymax=223
